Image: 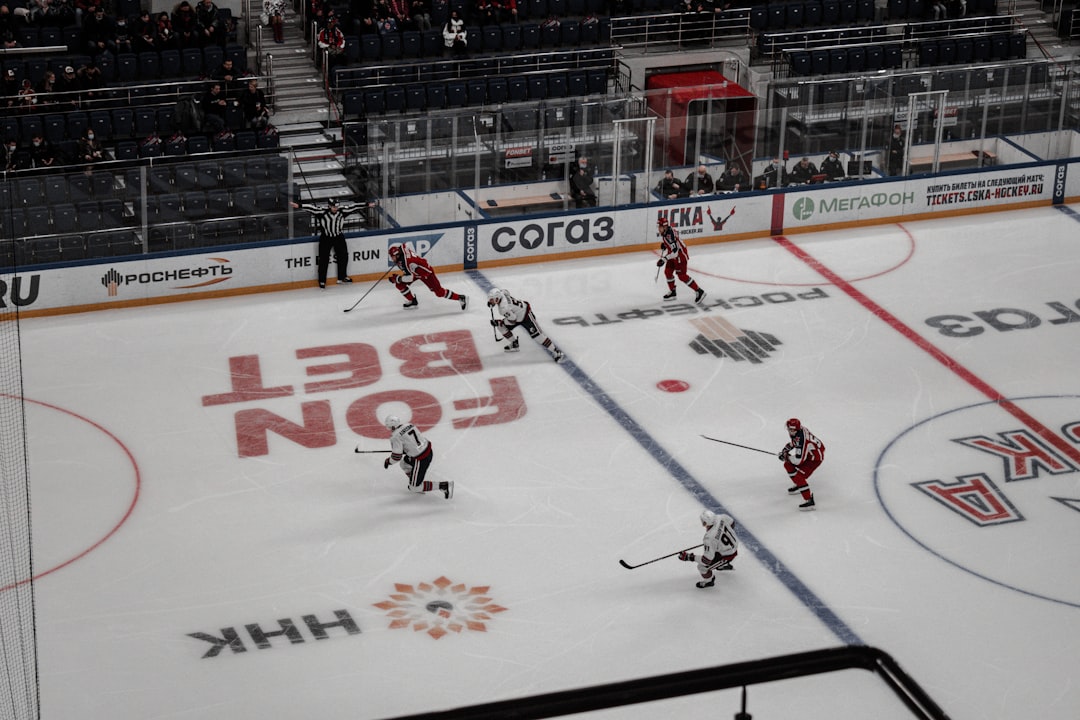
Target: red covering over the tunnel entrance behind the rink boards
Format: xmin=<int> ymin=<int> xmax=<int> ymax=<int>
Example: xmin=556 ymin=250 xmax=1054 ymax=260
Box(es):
xmin=645 ymin=70 xmax=755 ymax=165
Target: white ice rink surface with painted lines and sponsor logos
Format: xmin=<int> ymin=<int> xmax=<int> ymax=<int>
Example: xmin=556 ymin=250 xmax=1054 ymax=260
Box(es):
xmin=10 ymin=206 xmax=1080 ymax=720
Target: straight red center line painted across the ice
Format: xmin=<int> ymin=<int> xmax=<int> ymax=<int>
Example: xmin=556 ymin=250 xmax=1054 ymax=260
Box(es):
xmin=772 ymin=235 xmax=1080 ymax=467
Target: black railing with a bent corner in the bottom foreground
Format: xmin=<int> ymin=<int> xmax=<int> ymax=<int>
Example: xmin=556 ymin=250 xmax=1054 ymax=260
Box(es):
xmin=384 ymin=646 xmax=948 ymax=720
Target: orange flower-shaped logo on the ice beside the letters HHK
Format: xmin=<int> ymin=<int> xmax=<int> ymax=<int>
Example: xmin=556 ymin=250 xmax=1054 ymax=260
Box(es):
xmin=375 ymin=578 xmax=507 ymax=640
